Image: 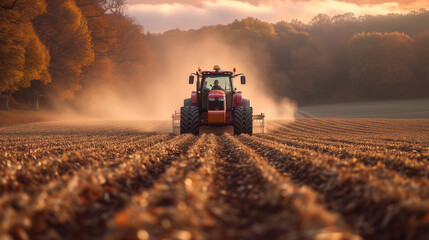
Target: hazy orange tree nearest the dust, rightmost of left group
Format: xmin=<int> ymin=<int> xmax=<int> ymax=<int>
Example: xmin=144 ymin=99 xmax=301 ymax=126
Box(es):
xmin=75 ymin=0 xmax=152 ymax=113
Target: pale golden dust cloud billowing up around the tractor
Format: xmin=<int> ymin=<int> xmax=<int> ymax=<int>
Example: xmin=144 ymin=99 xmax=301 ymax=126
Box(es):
xmin=74 ymin=31 xmax=296 ymax=123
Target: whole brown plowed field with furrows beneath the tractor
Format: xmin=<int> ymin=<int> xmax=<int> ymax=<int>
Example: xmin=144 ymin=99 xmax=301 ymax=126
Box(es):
xmin=0 ymin=119 xmax=429 ymax=240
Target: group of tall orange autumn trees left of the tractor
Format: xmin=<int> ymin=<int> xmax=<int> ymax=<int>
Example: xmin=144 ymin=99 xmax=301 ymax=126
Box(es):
xmin=0 ymin=0 xmax=151 ymax=109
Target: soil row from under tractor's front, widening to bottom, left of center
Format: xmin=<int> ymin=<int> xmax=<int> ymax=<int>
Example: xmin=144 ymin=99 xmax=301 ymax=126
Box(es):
xmin=105 ymin=134 xmax=217 ymax=239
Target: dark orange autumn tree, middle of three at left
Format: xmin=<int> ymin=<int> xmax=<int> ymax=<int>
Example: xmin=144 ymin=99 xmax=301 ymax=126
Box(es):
xmin=35 ymin=0 xmax=94 ymax=100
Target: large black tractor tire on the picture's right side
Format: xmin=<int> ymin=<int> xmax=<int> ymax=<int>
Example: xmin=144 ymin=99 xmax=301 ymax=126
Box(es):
xmin=233 ymin=106 xmax=253 ymax=135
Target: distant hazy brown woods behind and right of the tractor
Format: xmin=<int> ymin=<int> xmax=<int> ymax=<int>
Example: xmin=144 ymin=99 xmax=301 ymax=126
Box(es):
xmin=149 ymin=9 xmax=429 ymax=105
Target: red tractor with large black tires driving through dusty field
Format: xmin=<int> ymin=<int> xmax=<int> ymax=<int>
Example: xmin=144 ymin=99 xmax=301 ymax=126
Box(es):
xmin=172 ymin=65 xmax=265 ymax=135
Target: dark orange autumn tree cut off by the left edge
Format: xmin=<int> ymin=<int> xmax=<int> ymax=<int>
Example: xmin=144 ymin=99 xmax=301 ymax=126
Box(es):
xmin=0 ymin=0 xmax=51 ymax=109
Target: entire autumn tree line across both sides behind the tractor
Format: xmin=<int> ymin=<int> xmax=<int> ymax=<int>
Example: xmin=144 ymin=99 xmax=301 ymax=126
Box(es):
xmin=0 ymin=0 xmax=429 ymax=108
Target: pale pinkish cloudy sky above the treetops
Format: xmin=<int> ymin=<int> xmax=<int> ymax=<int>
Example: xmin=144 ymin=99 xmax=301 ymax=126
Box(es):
xmin=127 ymin=0 xmax=429 ymax=33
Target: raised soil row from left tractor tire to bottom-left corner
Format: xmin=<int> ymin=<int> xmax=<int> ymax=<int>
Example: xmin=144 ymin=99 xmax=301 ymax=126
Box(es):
xmin=0 ymin=135 xmax=196 ymax=239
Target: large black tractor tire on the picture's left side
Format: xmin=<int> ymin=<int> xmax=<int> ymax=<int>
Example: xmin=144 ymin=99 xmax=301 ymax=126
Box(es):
xmin=180 ymin=106 xmax=200 ymax=136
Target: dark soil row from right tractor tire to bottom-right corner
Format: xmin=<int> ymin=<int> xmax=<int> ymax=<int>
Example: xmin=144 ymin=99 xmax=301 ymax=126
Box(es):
xmin=239 ymin=135 xmax=429 ymax=239
